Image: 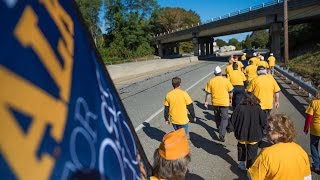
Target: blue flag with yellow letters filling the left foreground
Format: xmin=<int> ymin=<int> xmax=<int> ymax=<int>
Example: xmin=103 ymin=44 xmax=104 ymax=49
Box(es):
xmin=0 ymin=0 xmax=150 ymax=179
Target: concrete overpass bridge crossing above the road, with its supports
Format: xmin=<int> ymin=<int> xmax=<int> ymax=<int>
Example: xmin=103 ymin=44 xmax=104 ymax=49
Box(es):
xmin=154 ymin=0 xmax=320 ymax=59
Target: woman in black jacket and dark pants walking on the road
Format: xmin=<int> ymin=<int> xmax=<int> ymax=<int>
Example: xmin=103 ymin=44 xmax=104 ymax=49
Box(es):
xmin=229 ymin=93 xmax=267 ymax=170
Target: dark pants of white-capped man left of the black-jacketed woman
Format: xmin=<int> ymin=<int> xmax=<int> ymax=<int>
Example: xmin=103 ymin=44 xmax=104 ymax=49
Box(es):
xmin=213 ymin=106 xmax=229 ymax=137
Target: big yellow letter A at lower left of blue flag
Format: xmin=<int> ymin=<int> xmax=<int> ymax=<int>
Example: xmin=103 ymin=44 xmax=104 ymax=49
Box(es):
xmin=0 ymin=66 xmax=67 ymax=179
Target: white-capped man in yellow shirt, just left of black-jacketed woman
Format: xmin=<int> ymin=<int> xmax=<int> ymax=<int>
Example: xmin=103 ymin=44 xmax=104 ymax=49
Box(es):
xmin=204 ymin=66 xmax=233 ymax=142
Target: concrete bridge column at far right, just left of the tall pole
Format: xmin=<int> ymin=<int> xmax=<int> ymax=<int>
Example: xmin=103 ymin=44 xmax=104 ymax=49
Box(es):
xmin=270 ymin=23 xmax=282 ymax=61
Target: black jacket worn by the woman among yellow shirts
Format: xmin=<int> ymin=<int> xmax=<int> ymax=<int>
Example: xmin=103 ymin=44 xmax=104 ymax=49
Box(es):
xmin=228 ymin=105 xmax=267 ymax=142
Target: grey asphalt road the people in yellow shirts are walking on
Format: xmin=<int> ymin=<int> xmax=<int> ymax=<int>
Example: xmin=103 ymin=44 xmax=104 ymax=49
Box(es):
xmin=116 ymin=58 xmax=319 ymax=180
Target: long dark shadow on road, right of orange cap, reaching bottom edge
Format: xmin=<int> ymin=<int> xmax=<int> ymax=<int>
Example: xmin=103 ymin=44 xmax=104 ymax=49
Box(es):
xmin=190 ymin=132 xmax=247 ymax=179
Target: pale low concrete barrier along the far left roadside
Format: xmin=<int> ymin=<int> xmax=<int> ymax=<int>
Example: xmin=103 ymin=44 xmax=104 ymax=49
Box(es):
xmin=107 ymin=56 xmax=198 ymax=80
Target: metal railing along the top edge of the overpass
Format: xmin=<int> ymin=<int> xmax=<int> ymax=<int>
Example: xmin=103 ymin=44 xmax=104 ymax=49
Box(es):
xmin=154 ymin=0 xmax=283 ymax=37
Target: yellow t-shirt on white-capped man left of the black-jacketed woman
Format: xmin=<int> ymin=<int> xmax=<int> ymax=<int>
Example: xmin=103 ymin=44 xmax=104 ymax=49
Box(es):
xmin=205 ymin=76 xmax=233 ymax=106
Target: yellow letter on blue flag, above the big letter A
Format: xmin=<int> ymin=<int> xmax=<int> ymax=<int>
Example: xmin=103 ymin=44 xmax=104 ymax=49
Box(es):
xmin=14 ymin=6 xmax=73 ymax=102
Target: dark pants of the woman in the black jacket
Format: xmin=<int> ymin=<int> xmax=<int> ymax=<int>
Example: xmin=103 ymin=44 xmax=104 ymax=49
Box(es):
xmin=237 ymin=142 xmax=258 ymax=169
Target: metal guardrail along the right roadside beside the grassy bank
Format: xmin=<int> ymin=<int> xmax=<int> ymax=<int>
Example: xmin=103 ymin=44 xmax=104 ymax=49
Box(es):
xmin=275 ymin=65 xmax=317 ymax=97
